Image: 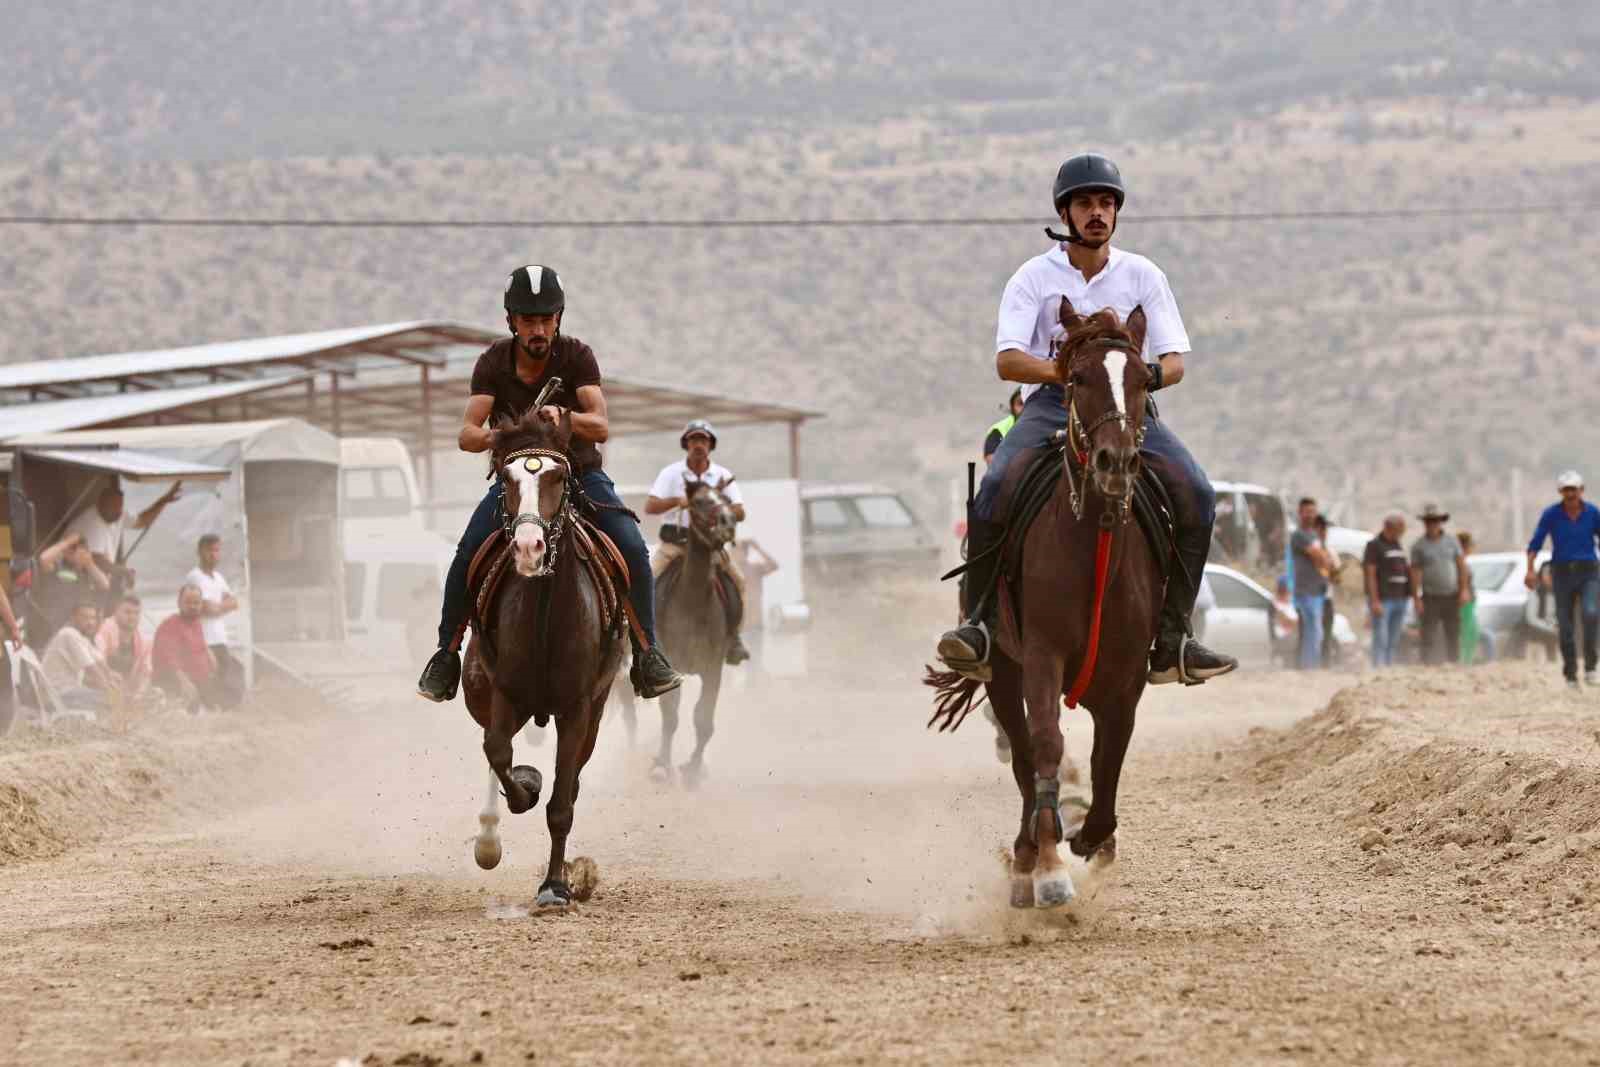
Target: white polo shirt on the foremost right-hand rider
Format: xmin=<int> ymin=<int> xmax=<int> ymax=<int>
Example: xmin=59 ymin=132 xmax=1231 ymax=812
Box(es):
xmin=995 ymin=245 xmax=1189 ymax=400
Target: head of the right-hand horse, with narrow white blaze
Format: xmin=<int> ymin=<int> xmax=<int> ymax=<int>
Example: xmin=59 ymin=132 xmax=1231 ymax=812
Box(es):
xmin=1056 ymin=298 xmax=1150 ymax=501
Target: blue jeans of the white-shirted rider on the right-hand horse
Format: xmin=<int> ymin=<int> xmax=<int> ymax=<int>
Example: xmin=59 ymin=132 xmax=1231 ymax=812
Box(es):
xmin=973 ymin=386 xmax=1216 ymax=617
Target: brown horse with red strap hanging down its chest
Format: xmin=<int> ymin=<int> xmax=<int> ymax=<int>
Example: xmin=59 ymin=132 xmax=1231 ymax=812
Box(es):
xmin=928 ymin=299 xmax=1162 ymax=907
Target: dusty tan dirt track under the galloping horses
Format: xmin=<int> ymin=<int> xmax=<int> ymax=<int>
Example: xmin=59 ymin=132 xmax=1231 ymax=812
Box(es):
xmin=0 ymin=655 xmax=1600 ymax=1064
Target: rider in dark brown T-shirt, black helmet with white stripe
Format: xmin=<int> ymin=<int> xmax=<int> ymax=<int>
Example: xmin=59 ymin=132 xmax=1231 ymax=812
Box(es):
xmin=416 ymin=264 xmax=683 ymax=701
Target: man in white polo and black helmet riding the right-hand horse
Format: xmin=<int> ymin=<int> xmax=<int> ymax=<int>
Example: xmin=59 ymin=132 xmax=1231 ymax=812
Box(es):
xmin=939 ymin=152 xmax=1238 ymax=685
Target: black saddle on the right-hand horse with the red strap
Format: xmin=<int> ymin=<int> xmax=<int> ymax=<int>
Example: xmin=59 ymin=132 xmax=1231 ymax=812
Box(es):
xmin=974 ymin=430 xmax=1179 ymax=629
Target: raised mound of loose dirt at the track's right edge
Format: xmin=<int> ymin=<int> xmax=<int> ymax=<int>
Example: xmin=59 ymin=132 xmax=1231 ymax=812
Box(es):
xmin=1248 ymin=664 xmax=1600 ymax=883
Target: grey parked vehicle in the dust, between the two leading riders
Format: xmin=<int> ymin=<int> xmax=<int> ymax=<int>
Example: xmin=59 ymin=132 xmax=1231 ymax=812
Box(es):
xmin=800 ymin=483 xmax=939 ymax=566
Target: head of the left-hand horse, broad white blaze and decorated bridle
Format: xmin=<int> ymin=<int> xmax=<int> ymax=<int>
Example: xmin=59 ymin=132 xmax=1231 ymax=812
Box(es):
xmin=490 ymin=410 xmax=573 ymax=577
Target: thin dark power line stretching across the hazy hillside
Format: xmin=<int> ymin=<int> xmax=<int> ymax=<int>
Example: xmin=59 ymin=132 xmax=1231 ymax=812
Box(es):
xmin=0 ymin=203 xmax=1597 ymax=230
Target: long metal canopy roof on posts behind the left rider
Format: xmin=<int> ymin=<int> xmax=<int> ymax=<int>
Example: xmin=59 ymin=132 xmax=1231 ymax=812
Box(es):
xmin=0 ymin=320 xmax=821 ymax=485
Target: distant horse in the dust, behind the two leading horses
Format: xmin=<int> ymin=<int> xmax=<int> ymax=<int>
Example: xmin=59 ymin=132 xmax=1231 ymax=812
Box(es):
xmin=651 ymin=480 xmax=736 ymax=787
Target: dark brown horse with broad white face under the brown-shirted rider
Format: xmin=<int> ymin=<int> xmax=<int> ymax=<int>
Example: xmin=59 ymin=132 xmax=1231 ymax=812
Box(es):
xmin=462 ymin=410 xmax=626 ymax=907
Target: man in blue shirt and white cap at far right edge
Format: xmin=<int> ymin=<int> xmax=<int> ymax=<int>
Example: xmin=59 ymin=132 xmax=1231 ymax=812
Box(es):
xmin=1523 ymin=470 xmax=1600 ymax=689
